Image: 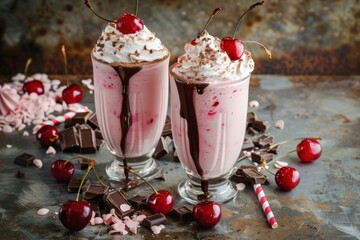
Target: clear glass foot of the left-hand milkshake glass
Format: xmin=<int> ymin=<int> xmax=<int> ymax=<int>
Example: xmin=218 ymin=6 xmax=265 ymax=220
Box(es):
xmin=105 ymin=156 xmax=163 ymax=181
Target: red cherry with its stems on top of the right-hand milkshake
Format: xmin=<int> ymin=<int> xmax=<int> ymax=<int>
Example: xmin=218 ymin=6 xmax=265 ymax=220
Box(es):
xmin=220 ymin=1 xmax=271 ymax=61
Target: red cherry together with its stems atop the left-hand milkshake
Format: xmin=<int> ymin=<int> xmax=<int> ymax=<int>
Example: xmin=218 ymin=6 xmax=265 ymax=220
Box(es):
xmin=85 ymin=0 xmax=144 ymax=34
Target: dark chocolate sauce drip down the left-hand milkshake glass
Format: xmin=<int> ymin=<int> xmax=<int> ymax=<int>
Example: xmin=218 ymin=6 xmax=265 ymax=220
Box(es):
xmin=113 ymin=66 xmax=142 ymax=179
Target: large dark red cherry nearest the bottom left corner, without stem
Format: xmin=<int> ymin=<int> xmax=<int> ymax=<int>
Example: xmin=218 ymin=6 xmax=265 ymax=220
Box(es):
xmin=59 ymin=201 xmax=92 ymax=232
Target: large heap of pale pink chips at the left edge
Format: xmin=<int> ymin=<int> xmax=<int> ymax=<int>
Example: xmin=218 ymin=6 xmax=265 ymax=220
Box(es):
xmin=0 ymin=73 xmax=90 ymax=133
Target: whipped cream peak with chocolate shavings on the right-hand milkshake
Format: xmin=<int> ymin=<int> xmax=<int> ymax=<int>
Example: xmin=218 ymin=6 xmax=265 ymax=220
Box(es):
xmin=172 ymin=31 xmax=254 ymax=83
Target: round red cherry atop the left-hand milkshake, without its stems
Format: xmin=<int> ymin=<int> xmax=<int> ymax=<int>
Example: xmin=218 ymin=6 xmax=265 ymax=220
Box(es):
xmin=116 ymin=13 xmax=144 ymax=34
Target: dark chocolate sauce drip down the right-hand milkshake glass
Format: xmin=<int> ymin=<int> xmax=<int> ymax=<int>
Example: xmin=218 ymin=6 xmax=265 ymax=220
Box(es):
xmin=175 ymin=79 xmax=209 ymax=198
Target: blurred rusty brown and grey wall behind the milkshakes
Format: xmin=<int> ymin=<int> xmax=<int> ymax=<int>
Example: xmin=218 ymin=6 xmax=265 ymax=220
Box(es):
xmin=0 ymin=0 xmax=360 ymax=75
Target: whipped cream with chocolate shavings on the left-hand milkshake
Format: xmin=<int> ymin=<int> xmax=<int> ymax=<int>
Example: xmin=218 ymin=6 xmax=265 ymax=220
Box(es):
xmin=93 ymin=22 xmax=169 ymax=64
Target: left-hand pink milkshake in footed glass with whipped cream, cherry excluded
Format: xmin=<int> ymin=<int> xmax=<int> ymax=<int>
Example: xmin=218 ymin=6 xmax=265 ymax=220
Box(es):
xmin=91 ymin=23 xmax=170 ymax=180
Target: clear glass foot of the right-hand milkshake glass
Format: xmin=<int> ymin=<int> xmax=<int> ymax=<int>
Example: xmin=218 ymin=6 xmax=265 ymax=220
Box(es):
xmin=178 ymin=176 xmax=237 ymax=204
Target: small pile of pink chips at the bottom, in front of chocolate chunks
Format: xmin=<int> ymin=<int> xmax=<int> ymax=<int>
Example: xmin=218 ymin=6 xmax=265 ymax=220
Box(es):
xmin=90 ymin=208 xmax=165 ymax=236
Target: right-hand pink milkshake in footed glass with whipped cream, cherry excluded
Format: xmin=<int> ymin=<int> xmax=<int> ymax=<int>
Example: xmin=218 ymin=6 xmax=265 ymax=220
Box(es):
xmin=170 ymin=31 xmax=254 ymax=203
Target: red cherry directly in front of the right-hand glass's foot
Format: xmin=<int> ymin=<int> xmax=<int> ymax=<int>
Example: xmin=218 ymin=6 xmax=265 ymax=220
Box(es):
xmin=193 ymin=201 xmax=221 ymax=228
